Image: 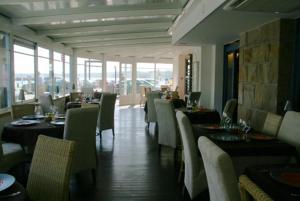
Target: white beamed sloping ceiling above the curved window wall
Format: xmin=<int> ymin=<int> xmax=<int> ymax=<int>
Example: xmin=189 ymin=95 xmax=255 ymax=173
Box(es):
xmin=0 ymin=0 xmax=192 ymax=58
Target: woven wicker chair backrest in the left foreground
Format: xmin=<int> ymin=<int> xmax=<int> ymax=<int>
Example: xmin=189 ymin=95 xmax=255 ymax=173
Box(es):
xmin=26 ymin=135 xmax=75 ymax=201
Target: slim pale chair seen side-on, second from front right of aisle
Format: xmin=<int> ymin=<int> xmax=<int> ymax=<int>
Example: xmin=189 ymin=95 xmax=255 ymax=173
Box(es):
xmin=176 ymin=111 xmax=207 ymax=199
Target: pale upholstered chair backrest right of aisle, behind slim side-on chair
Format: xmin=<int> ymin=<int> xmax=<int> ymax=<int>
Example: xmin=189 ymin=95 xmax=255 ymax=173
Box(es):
xmin=154 ymin=99 xmax=179 ymax=148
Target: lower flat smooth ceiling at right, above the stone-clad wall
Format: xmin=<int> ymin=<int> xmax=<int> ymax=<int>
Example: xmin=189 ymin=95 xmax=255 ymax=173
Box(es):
xmin=177 ymin=0 xmax=300 ymax=45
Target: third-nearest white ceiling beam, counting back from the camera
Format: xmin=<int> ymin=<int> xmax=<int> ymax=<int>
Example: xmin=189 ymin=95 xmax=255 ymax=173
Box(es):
xmin=53 ymin=31 xmax=169 ymax=43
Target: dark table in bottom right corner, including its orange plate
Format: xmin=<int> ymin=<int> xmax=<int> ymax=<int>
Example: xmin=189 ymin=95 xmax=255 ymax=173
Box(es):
xmin=244 ymin=163 xmax=300 ymax=201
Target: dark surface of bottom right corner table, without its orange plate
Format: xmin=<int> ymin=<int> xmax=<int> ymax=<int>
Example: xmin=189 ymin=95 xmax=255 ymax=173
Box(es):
xmin=245 ymin=164 xmax=300 ymax=201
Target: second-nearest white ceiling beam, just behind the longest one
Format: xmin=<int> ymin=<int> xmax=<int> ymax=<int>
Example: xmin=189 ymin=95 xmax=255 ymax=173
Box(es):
xmin=37 ymin=22 xmax=172 ymax=37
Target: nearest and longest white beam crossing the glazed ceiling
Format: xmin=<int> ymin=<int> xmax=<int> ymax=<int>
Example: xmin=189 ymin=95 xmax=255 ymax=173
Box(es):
xmin=12 ymin=8 xmax=181 ymax=25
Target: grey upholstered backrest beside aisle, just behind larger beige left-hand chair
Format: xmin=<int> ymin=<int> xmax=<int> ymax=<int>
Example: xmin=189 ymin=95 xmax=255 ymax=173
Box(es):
xmin=98 ymin=93 xmax=117 ymax=131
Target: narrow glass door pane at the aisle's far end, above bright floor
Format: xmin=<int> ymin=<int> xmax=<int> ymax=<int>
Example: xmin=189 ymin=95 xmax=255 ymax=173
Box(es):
xmin=120 ymin=63 xmax=132 ymax=95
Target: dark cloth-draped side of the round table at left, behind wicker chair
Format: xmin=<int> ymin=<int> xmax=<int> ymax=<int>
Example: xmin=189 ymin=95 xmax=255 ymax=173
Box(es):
xmin=2 ymin=121 xmax=64 ymax=153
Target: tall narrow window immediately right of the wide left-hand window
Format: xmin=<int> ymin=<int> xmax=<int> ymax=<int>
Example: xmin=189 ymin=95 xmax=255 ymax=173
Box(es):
xmin=37 ymin=47 xmax=52 ymax=97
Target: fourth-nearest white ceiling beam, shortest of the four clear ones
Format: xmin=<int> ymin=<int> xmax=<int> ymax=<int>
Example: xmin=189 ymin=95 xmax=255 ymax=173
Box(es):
xmin=67 ymin=37 xmax=172 ymax=48
